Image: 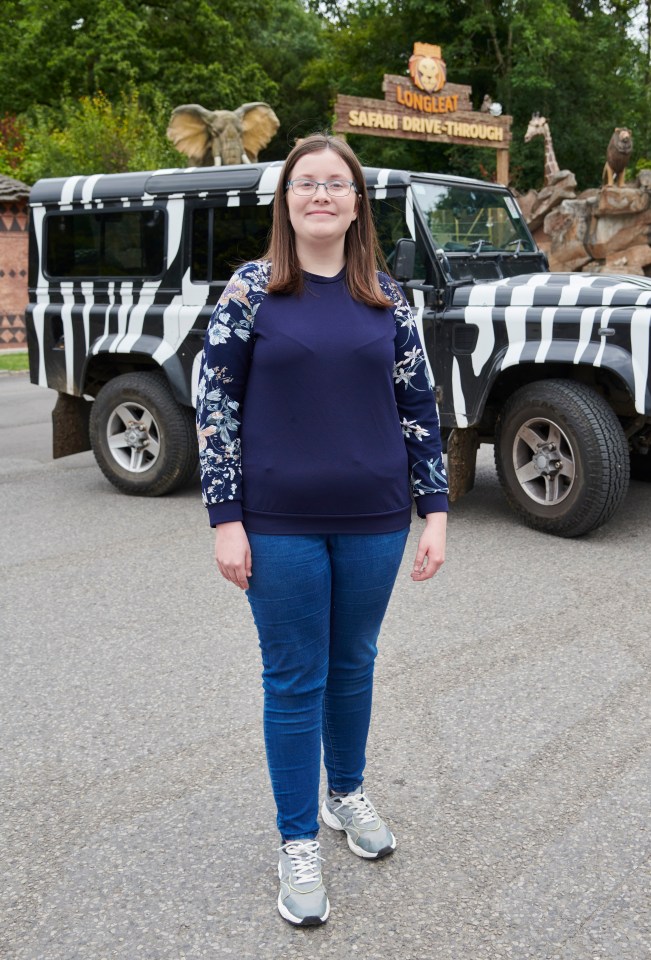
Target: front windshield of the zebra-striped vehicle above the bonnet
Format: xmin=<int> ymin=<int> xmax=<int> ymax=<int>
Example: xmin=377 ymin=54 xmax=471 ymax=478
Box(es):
xmin=412 ymin=182 xmax=536 ymax=254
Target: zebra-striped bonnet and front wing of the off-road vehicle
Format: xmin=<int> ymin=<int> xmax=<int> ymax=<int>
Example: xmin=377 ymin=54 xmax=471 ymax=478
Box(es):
xmin=447 ymin=273 xmax=651 ymax=427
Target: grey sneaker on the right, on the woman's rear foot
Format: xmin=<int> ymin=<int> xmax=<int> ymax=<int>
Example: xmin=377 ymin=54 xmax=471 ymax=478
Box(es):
xmin=321 ymin=786 xmax=396 ymax=860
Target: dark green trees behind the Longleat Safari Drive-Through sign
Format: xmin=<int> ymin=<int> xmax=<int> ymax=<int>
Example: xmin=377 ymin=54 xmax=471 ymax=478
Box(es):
xmin=304 ymin=0 xmax=649 ymax=188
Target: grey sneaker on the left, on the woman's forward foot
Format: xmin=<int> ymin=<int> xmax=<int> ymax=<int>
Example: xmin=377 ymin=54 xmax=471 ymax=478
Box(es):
xmin=278 ymin=840 xmax=330 ymax=927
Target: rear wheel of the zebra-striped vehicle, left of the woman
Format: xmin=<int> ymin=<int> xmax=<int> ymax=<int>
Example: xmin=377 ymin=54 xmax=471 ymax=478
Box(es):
xmin=90 ymin=371 xmax=198 ymax=497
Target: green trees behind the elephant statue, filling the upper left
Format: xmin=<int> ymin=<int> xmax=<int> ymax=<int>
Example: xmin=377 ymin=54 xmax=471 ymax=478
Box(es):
xmin=0 ymin=0 xmax=329 ymax=176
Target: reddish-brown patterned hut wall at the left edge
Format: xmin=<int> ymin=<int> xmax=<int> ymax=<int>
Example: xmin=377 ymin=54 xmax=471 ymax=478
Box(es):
xmin=0 ymin=200 xmax=27 ymax=350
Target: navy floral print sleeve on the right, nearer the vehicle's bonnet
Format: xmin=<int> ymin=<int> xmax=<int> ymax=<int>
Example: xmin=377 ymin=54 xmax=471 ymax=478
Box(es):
xmin=378 ymin=273 xmax=448 ymax=517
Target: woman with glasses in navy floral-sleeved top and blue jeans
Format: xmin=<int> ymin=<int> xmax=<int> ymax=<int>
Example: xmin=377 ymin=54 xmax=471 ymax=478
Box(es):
xmin=197 ymin=135 xmax=447 ymax=925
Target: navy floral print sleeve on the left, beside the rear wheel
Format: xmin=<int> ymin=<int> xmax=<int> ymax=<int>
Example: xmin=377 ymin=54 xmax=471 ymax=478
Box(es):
xmin=197 ymin=261 xmax=270 ymax=526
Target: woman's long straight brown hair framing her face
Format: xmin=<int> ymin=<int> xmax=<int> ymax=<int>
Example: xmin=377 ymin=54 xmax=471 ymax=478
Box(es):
xmin=264 ymin=133 xmax=391 ymax=307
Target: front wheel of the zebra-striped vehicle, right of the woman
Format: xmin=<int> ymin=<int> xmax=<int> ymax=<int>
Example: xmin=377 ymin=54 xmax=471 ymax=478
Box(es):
xmin=495 ymin=380 xmax=630 ymax=537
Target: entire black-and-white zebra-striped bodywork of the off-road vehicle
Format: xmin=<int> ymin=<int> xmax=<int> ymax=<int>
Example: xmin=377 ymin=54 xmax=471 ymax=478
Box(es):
xmin=27 ymin=162 xmax=651 ymax=427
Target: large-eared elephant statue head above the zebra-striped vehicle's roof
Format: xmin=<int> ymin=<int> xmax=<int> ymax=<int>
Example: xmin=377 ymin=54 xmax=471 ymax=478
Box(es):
xmin=167 ymin=103 xmax=280 ymax=167
